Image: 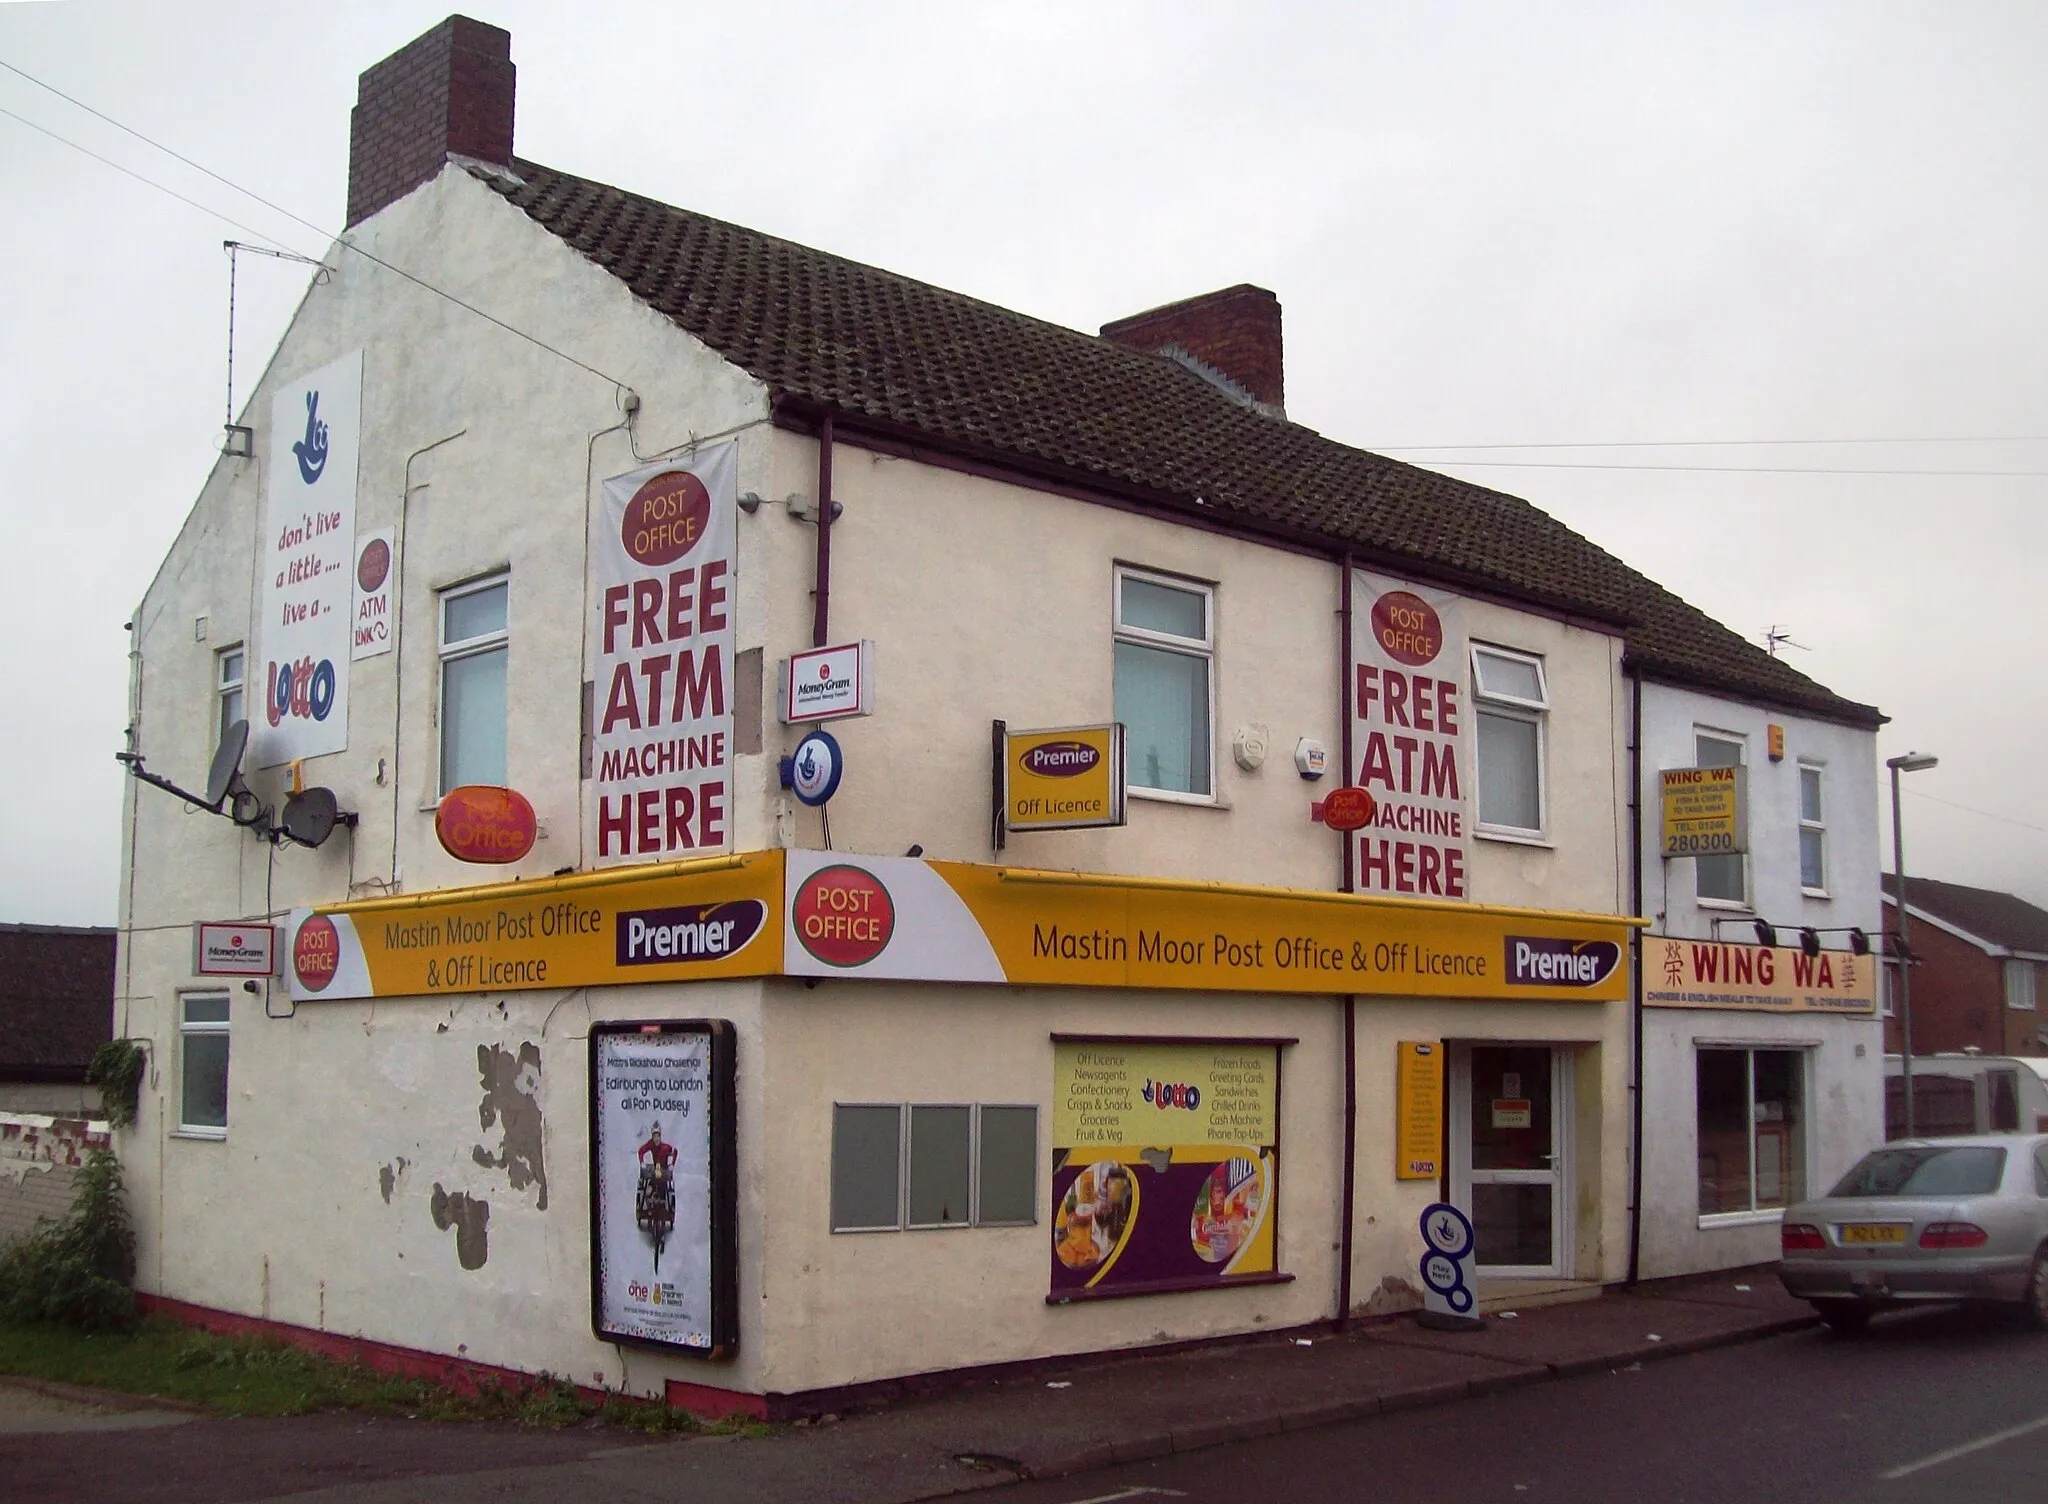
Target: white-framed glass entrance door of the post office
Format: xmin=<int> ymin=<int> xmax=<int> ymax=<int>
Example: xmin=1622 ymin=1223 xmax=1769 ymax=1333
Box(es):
xmin=1452 ymin=1045 xmax=1571 ymax=1277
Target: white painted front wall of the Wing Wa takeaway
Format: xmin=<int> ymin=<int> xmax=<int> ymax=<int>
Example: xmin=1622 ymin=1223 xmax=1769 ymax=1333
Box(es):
xmin=1640 ymin=684 xmax=1884 ymax=1277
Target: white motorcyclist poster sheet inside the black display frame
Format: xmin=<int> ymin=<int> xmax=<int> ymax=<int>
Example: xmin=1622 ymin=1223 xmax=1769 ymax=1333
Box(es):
xmin=590 ymin=1031 xmax=715 ymax=1352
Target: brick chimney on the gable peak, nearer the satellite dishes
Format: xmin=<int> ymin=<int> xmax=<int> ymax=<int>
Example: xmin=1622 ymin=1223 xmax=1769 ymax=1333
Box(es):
xmin=348 ymin=16 xmax=516 ymax=225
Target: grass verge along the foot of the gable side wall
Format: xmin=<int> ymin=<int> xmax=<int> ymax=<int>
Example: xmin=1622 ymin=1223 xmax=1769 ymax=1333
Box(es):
xmin=0 ymin=1315 xmax=754 ymax=1432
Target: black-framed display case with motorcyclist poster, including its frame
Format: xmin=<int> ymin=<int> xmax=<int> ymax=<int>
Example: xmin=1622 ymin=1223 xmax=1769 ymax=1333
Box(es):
xmin=590 ymin=1020 xmax=733 ymax=1356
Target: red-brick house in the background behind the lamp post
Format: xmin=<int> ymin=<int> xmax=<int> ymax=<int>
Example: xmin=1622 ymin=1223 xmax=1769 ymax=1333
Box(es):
xmin=1884 ymin=873 xmax=2048 ymax=1055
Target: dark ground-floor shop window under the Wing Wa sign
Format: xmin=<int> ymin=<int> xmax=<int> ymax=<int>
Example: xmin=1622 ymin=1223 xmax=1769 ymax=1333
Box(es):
xmin=1698 ymin=1045 xmax=1806 ymax=1217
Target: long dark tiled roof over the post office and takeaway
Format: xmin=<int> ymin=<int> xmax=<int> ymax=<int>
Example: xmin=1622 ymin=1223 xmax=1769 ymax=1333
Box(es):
xmin=475 ymin=162 xmax=1882 ymax=725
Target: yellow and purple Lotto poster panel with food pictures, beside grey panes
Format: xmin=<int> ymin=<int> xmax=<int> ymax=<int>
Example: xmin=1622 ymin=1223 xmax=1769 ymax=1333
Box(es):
xmin=1047 ymin=1039 xmax=1280 ymax=1303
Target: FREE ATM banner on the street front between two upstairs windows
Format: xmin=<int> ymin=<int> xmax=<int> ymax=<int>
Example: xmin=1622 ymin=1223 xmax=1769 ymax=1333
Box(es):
xmin=1343 ymin=570 xmax=1475 ymax=897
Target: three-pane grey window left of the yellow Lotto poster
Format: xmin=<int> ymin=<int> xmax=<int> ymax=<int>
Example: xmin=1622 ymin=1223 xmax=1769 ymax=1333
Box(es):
xmin=831 ymin=1102 xmax=1038 ymax=1231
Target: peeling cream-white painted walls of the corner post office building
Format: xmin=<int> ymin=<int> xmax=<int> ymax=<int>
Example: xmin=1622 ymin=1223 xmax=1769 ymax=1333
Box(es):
xmin=117 ymin=158 xmax=1626 ymax=1393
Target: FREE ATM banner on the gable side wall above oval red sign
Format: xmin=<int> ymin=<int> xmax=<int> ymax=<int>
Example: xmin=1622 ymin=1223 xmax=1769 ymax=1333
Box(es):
xmin=584 ymin=443 xmax=739 ymax=867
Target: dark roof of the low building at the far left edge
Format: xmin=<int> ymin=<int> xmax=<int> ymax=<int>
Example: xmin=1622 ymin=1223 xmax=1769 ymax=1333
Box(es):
xmin=0 ymin=924 xmax=115 ymax=1082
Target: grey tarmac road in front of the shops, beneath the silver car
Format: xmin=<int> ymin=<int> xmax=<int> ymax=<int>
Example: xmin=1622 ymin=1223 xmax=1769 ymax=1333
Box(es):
xmin=981 ymin=1309 xmax=2048 ymax=1504
